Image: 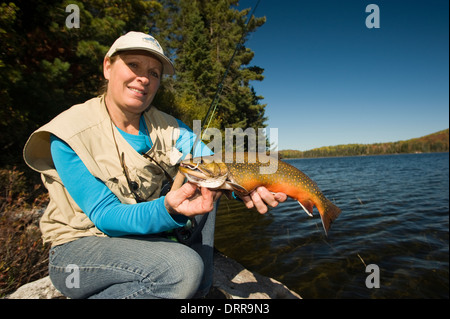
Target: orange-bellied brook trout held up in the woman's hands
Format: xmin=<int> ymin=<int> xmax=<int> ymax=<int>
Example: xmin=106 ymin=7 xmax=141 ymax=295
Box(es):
xmin=179 ymin=153 xmax=341 ymax=234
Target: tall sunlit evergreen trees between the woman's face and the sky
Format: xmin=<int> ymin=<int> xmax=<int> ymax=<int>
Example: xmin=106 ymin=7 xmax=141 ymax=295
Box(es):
xmin=162 ymin=0 xmax=266 ymax=142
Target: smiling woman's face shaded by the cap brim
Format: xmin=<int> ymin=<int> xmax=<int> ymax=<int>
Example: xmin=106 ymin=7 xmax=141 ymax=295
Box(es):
xmin=103 ymin=51 xmax=162 ymax=114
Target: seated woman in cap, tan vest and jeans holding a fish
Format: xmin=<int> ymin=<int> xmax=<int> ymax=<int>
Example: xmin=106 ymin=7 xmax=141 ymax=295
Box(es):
xmin=24 ymin=32 xmax=286 ymax=298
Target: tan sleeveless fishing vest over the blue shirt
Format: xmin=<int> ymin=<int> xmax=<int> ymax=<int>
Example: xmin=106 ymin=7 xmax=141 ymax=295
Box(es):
xmin=24 ymin=96 xmax=179 ymax=246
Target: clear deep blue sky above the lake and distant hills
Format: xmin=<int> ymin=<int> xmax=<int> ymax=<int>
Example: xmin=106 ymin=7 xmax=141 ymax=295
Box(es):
xmin=239 ymin=0 xmax=449 ymax=150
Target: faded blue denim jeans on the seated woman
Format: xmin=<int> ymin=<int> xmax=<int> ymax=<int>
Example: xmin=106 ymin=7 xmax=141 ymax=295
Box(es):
xmin=49 ymin=203 xmax=218 ymax=299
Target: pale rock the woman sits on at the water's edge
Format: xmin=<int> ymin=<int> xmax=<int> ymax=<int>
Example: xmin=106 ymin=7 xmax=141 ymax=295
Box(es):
xmin=6 ymin=252 xmax=301 ymax=299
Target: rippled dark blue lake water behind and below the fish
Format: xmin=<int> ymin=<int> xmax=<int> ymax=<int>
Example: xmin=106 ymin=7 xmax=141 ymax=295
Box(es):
xmin=216 ymin=153 xmax=449 ymax=299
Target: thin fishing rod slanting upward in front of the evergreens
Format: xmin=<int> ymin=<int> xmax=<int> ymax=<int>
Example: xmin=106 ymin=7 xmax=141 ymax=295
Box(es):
xmin=191 ymin=0 xmax=261 ymax=156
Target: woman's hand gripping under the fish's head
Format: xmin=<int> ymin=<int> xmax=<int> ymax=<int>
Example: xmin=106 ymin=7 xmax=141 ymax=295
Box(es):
xmin=164 ymin=182 xmax=222 ymax=217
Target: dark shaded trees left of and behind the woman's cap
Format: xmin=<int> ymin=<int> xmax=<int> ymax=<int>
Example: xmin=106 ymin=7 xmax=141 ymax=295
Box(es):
xmin=0 ymin=0 xmax=162 ymax=166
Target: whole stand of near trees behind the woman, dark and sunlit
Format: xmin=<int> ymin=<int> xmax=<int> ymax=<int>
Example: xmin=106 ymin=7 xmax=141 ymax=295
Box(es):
xmin=0 ymin=0 xmax=266 ymax=167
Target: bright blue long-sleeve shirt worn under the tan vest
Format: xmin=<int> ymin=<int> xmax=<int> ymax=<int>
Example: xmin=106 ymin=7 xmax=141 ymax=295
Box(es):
xmin=51 ymin=118 xmax=212 ymax=236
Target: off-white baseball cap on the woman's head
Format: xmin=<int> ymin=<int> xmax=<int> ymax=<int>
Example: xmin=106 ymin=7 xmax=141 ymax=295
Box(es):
xmin=106 ymin=31 xmax=175 ymax=75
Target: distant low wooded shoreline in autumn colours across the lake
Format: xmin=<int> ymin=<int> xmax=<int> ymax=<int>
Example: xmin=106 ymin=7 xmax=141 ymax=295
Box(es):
xmin=280 ymin=129 xmax=449 ymax=158
